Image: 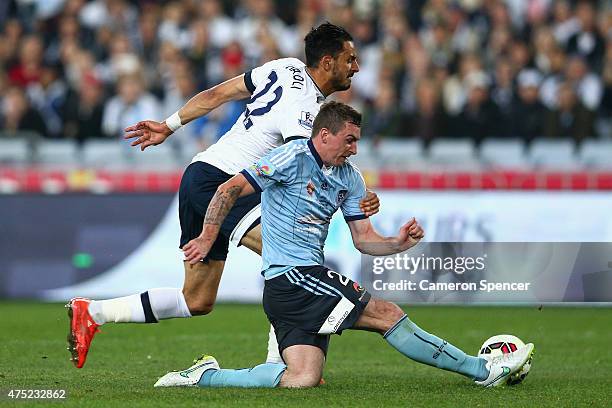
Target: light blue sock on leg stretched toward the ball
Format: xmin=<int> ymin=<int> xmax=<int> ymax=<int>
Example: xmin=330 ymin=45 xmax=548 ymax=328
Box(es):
xmin=384 ymin=315 xmax=489 ymax=380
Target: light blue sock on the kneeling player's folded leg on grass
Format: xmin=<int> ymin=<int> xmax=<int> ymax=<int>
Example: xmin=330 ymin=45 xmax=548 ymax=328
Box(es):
xmin=198 ymin=363 xmax=287 ymax=388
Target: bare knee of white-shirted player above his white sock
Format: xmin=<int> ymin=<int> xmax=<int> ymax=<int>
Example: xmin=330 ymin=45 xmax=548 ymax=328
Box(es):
xmin=183 ymin=260 xmax=225 ymax=316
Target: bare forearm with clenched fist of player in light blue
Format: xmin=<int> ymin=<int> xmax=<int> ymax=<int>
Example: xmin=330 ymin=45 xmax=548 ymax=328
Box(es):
xmin=348 ymin=218 xmax=425 ymax=255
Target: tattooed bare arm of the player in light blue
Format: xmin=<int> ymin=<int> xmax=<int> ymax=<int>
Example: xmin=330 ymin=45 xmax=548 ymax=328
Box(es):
xmin=182 ymin=173 xmax=255 ymax=265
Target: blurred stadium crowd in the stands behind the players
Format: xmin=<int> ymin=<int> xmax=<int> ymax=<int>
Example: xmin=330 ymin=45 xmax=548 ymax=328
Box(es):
xmin=0 ymin=0 xmax=612 ymax=150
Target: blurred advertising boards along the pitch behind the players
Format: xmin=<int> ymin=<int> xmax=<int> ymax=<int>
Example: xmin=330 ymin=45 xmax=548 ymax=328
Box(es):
xmin=0 ymin=190 xmax=612 ymax=304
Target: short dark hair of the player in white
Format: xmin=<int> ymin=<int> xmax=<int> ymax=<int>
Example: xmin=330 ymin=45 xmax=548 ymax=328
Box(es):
xmin=304 ymin=21 xmax=353 ymax=68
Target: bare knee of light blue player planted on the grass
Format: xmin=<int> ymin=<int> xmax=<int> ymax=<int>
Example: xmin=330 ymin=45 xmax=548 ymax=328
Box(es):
xmin=279 ymin=344 xmax=325 ymax=388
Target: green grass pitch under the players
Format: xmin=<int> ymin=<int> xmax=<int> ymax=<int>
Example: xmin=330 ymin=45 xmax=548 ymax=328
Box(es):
xmin=0 ymin=302 xmax=612 ymax=408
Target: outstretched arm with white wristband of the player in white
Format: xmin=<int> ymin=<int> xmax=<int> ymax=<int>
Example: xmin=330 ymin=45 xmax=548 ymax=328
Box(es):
xmin=124 ymin=74 xmax=251 ymax=150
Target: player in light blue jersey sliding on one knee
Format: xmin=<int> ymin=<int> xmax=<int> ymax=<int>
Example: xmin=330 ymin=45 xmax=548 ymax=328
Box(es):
xmin=155 ymin=102 xmax=533 ymax=387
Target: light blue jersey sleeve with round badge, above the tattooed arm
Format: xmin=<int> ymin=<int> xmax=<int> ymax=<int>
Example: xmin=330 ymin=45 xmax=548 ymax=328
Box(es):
xmin=240 ymin=145 xmax=297 ymax=192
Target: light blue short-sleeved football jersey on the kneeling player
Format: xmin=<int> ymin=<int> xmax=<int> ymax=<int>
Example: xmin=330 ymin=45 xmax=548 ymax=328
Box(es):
xmin=241 ymin=139 xmax=366 ymax=279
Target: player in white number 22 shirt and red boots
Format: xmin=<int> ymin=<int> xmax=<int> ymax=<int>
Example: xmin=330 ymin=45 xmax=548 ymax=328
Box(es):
xmin=66 ymin=23 xmax=379 ymax=368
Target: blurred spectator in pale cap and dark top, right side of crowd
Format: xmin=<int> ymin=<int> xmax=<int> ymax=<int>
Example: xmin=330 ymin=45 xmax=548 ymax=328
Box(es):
xmin=510 ymin=69 xmax=546 ymax=141
